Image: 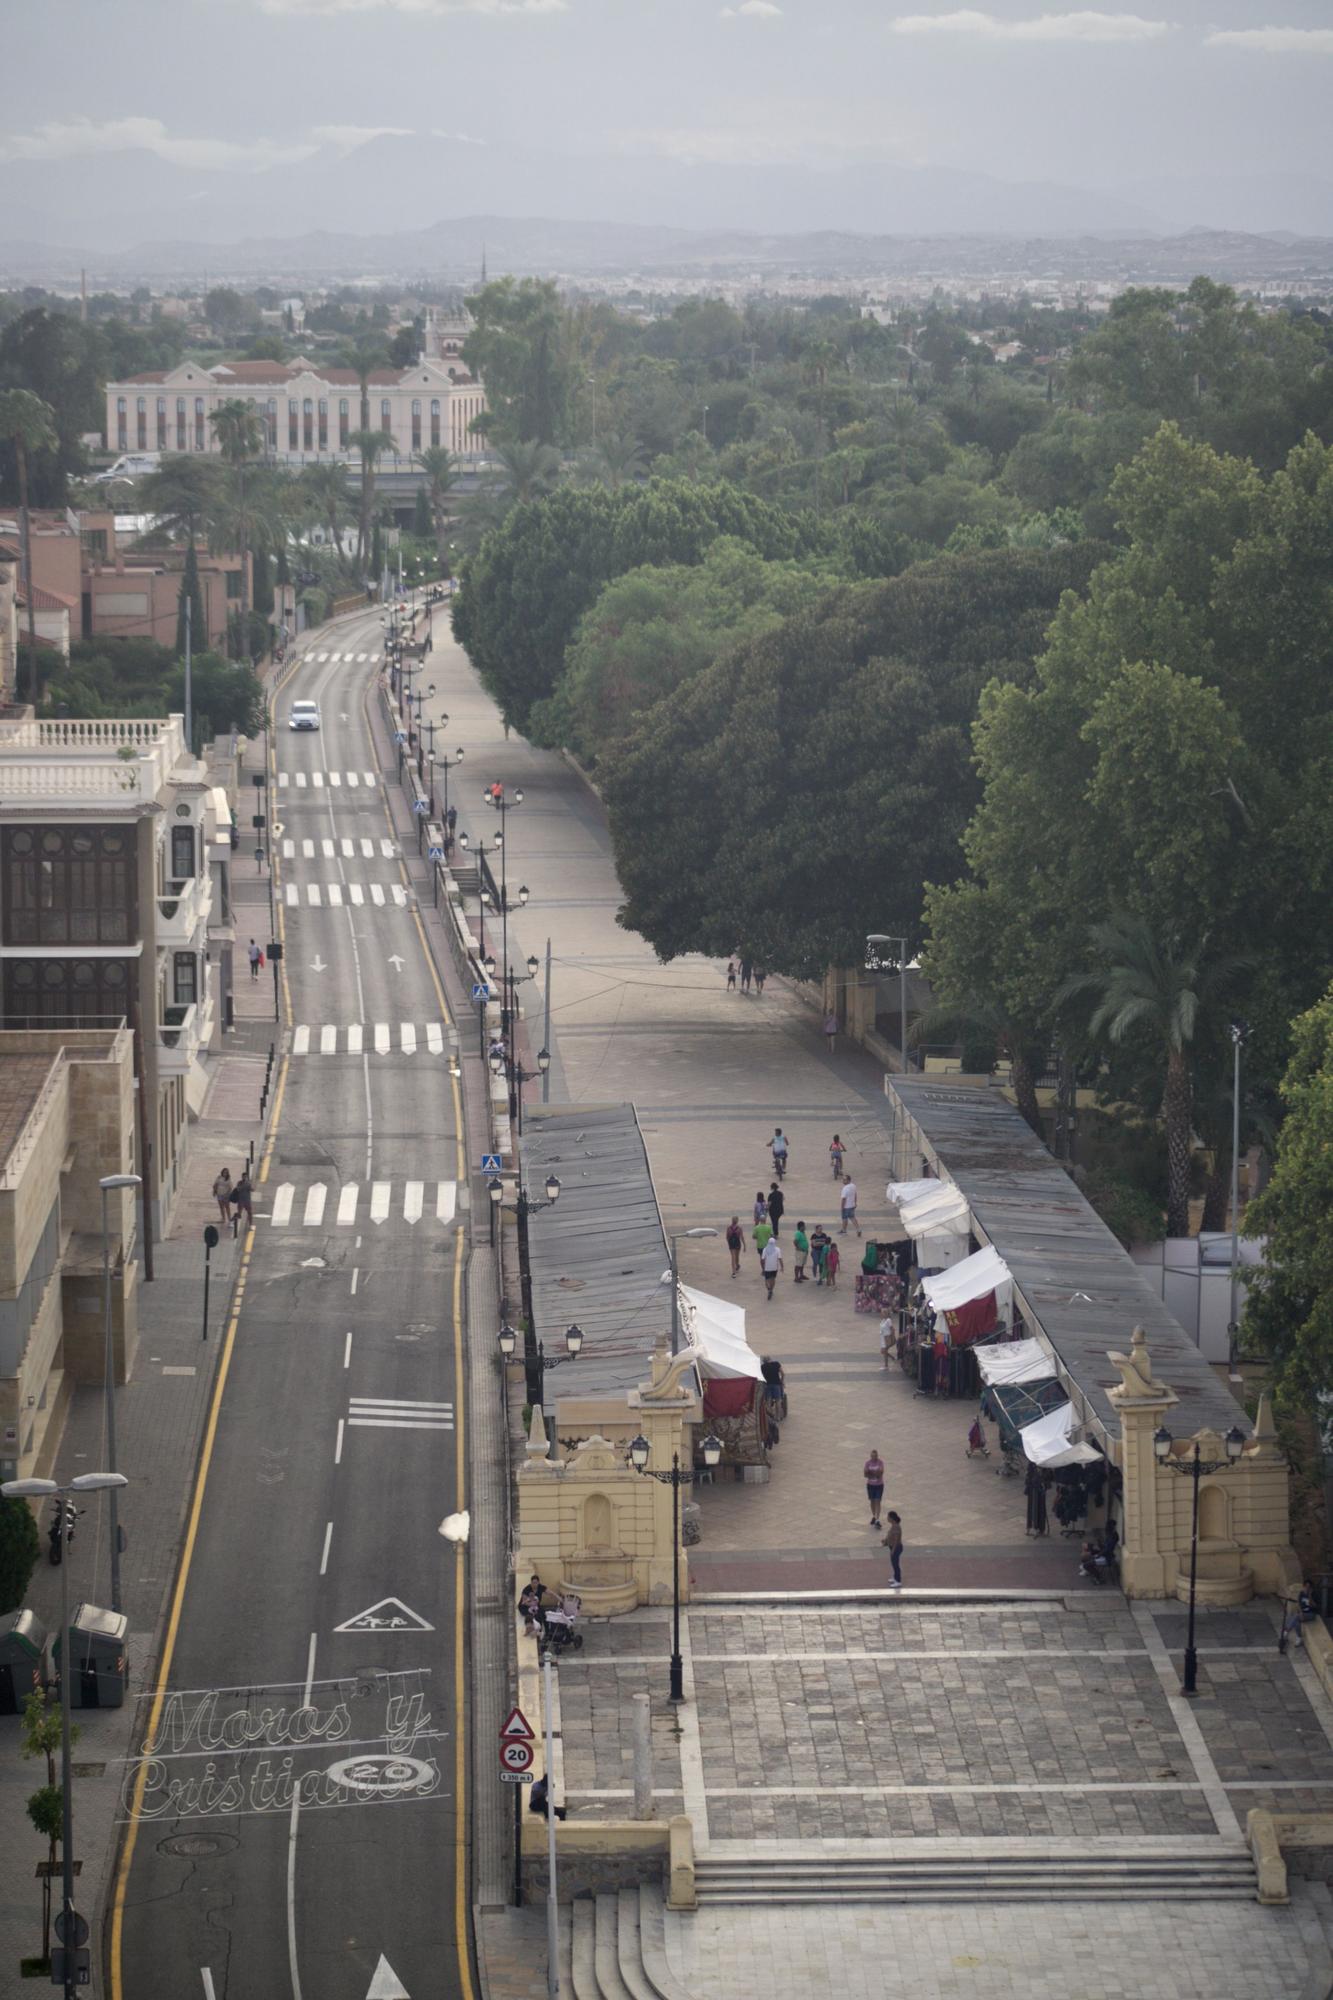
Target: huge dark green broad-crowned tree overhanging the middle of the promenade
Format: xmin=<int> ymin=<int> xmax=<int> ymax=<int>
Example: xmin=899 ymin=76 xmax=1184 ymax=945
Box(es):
xmin=602 ymin=546 xmax=1097 ymax=978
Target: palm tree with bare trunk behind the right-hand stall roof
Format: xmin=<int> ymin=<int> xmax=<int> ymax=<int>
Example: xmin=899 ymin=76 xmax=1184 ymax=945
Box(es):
xmin=1057 ymin=912 xmax=1241 ymax=1236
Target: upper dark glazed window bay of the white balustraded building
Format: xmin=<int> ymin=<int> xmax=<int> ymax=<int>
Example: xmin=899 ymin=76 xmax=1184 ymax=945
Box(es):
xmin=0 ymin=826 xmax=138 ymax=944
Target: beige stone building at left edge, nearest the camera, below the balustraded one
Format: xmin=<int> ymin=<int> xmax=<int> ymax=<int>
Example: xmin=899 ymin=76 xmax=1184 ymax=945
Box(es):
xmin=0 ymin=1026 xmax=138 ymax=1480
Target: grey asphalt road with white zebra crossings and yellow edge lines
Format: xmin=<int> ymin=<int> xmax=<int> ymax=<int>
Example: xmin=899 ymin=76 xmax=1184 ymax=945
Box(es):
xmin=112 ymin=614 xmax=470 ymax=2000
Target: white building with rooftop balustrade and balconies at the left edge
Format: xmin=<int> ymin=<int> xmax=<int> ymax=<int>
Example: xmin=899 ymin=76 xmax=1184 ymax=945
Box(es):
xmin=0 ymin=714 xmax=220 ymax=1230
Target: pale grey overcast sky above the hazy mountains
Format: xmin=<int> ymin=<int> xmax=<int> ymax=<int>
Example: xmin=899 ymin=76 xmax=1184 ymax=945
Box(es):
xmin=0 ymin=0 xmax=1333 ymax=186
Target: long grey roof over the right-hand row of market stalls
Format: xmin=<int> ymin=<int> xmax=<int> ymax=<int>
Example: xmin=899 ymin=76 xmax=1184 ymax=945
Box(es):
xmin=885 ymin=1076 xmax=1251 ymax=1438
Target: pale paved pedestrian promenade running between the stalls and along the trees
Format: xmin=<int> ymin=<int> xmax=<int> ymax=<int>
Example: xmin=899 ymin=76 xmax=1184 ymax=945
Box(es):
xmin=434 ymin=628 xmax=1091 ymax=1590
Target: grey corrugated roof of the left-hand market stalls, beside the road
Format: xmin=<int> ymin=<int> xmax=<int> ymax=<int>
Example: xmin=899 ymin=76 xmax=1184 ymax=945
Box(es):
xmin=520 ymin=1104 xmax=671 ymax=1396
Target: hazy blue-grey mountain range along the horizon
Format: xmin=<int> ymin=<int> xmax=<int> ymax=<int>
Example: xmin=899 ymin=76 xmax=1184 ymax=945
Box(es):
xmin=0 ymin=134 xmax=1333 ymax=276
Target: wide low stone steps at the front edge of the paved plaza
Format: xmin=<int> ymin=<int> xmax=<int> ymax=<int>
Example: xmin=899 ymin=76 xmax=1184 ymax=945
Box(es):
xmin=695 ymin=1838 xmax=1259 ymax=1906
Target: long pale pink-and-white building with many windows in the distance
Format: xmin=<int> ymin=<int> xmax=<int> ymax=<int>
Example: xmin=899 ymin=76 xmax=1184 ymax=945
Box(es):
xmin=106 ymin=306 xmax=486 ymax=466
